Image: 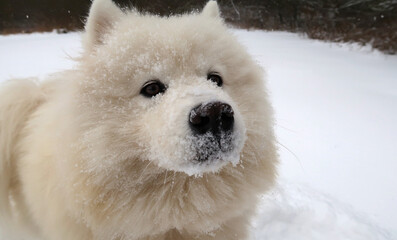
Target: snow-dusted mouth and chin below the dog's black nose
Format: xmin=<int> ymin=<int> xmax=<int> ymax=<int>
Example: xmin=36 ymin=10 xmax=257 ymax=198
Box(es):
xmin=148 ymin=125 xmax=246 ymax=177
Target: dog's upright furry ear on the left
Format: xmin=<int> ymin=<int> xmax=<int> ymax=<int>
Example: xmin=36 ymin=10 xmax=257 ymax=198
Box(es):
xmin=83 ymin=0 xmax=124 ymax=51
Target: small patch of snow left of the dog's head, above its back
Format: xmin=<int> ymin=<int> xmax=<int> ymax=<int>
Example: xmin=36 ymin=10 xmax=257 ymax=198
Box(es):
xmin=0 ymin=33 xmax=82 ymax=81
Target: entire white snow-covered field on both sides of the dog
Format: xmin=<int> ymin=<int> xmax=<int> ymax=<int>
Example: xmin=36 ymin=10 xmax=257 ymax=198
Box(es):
xmin=0 ymin=30 xmax=397 ymax=240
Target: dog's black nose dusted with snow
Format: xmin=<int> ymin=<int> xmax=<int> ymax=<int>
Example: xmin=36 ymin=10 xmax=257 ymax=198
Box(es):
xmin=189 ymin=102 xmax=234 ymax=134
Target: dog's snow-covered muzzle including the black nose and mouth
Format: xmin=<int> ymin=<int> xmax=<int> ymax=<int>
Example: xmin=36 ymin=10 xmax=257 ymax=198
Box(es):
xmin=142 ymin=83 xmax=246 ymax=175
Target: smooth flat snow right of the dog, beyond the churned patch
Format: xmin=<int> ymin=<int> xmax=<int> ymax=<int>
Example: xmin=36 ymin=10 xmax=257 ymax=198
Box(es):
xmin=232 ymin=31 xmax=397 ymax=239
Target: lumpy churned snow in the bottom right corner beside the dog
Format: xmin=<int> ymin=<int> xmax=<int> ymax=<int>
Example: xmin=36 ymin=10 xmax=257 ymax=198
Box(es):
xmin=253 ymin=182 xmax=392 ymax=240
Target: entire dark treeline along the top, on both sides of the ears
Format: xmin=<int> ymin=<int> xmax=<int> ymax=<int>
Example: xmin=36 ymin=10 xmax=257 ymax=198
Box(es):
xmin=0 ymin=0 xmax=397 ymax=54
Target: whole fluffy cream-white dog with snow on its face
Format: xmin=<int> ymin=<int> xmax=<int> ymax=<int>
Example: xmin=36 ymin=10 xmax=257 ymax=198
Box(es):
xmin=0 ymin=0 xmax=277 ymax=240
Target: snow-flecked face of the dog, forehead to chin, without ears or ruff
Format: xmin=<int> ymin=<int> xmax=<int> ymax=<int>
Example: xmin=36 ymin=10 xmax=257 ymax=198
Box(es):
xmin=76 ymin=0 xmax=260 ymax=175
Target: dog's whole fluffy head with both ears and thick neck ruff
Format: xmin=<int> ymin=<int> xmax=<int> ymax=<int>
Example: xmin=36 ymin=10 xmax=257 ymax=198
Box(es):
xmin=66 ymin=0 xmax=275 ymax=236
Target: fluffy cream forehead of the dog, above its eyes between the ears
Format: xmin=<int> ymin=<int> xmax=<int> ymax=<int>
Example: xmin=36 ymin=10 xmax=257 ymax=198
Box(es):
xmin=98 ymin=16 xmax=225 ymax=75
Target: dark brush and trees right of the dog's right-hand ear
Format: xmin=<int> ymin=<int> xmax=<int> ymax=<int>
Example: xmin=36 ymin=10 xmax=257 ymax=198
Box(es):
xmin=221 ymin=0 xmax=397 ymax=54
